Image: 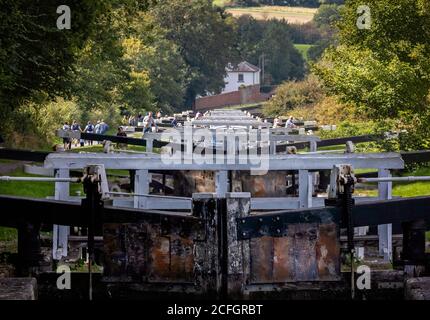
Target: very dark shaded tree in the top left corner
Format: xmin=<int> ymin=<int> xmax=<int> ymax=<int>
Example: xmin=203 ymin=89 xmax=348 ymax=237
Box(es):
xmin=0 ymin=0 xmax=108 ymax=131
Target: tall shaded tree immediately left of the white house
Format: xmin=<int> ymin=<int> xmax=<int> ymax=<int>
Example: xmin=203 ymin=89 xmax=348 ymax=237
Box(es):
xmin=151 ymin=0 xmax=234 ymax=106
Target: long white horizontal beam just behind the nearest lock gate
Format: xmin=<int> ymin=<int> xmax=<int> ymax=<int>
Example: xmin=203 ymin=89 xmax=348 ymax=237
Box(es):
xmin=44 ymin=153 xmax=404 ymax=171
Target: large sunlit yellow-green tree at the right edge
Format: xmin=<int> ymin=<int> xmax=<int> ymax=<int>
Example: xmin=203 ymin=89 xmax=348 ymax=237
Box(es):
xmin=314 ymin=0 xmax=430 ymax=150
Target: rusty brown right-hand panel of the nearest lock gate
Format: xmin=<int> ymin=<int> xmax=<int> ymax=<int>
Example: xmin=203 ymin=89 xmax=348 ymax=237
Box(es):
xmin=249 ymin=223 xmax=340 ymax=284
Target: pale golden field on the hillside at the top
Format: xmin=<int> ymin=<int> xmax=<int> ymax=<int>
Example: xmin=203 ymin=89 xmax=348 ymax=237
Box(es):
xmin=226 ymin=6 xmax=317 ymax=24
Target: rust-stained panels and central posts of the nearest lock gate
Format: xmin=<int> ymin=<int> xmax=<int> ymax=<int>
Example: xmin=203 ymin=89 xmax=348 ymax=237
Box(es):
xmin=103 ymin=193 xmax=341 ymax=298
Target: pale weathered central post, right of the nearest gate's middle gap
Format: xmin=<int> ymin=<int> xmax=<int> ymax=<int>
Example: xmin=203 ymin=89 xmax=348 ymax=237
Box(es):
xmin=226 ymin=192 xmax=251 ymax=299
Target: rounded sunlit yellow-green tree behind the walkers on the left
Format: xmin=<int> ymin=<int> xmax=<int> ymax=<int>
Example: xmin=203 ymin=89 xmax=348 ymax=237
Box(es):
xmin=74 ymin=5 xmax=187 ymax=113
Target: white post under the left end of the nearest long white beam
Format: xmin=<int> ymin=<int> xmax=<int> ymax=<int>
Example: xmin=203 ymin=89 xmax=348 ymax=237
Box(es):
xmin=52 ymin=169 xmax=70 ymax=260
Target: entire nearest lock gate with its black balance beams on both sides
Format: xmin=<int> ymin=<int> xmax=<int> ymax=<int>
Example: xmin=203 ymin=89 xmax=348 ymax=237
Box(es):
xmin=0 ymin=175 xmax=430 ymax=298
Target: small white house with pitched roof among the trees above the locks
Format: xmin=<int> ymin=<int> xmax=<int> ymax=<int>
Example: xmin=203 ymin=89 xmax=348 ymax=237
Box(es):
xmin=222 ymin=61 xmax=261 ymax=93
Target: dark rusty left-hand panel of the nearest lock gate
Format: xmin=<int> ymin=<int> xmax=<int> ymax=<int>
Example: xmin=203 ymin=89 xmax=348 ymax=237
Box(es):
xmin=104 ymin=223 xmax=194 ymax=283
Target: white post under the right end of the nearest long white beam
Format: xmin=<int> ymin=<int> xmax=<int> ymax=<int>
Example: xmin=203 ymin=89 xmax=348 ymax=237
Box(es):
xmin=378 ymin=169 xmax=393 ymax=261
